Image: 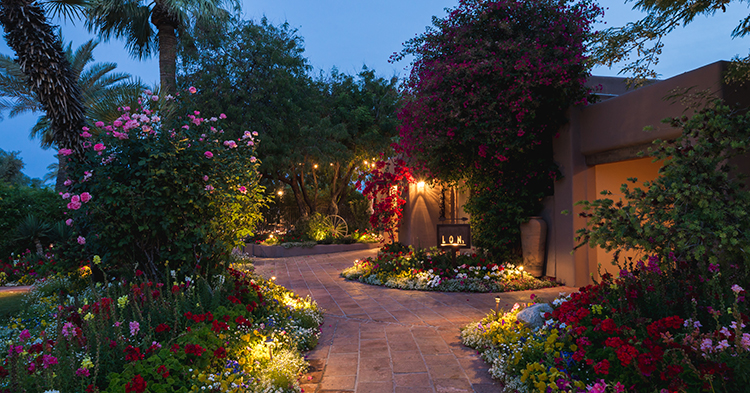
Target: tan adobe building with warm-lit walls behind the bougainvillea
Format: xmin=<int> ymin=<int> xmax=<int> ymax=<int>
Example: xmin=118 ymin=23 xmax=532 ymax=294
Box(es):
xmin=399 ymin=61 xmax=750 ymax=286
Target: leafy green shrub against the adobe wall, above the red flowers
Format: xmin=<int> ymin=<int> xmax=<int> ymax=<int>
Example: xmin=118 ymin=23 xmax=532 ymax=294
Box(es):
xmin=578 ymin=103 xmax=750 ymax=282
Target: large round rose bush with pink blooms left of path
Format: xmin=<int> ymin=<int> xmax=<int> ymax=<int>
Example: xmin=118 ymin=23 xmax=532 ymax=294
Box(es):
xmin=66 ymin=92 xmax=265 ymax=276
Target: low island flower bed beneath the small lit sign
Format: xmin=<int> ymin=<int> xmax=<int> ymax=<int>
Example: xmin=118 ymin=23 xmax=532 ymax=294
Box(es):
xmin=341 ymin=245 xmax=557 ymax=292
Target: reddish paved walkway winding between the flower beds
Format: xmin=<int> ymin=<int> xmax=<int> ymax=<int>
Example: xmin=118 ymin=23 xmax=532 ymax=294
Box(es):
xmin=255 ymin=250 xmax=574 ymax=393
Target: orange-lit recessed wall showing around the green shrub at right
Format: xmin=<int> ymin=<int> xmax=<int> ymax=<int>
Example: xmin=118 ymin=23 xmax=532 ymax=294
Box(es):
xmin=589 ymin=157 xmax=662 ymax=279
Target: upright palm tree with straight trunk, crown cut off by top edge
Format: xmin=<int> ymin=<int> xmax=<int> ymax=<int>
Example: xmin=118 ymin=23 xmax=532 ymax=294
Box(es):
xmin=86 ymin=0 xmax=240 ymax=94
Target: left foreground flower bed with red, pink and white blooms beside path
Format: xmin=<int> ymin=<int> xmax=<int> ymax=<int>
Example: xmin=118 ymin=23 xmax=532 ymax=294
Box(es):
xmin=0 ymin=260 xmax=322 ymax=393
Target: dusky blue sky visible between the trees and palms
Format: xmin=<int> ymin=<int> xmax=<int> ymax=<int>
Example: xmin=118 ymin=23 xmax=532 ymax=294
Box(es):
xmin=0 ymin=0 xmax=750 ymax=178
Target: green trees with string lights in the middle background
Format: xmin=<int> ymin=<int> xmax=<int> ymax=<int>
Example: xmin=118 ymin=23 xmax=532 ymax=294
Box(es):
xmin=179 ymin=18 xmax=400 ymax=216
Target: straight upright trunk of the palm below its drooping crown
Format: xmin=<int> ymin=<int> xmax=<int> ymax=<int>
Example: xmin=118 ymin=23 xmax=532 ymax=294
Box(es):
xmin=151 ymin=1 xmax=178 ymax=95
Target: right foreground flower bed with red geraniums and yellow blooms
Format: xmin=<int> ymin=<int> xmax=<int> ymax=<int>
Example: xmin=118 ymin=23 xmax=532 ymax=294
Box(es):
xmin=461 ymin=263 xmax=750 ymax=393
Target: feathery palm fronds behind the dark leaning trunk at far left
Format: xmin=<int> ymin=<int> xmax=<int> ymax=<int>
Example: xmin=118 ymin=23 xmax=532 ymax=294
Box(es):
xmin=0 ymin=40 xmax=145 ymax=149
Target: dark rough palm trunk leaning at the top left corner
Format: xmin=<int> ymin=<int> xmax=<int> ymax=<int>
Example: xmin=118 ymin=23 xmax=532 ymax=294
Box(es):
xmin=0 ymin=0 xmax=85 ymax=156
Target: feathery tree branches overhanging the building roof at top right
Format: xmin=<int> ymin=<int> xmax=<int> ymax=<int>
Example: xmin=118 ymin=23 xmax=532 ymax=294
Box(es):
xmin=592 ymin=0 xmax=750 ymax=85
